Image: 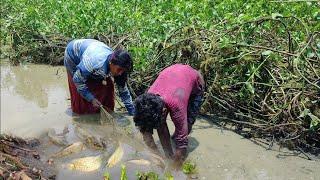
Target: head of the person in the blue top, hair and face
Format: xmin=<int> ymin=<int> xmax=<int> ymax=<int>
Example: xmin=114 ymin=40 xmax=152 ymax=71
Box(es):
xmin=110 ymin=50 xmax=133 ymax=76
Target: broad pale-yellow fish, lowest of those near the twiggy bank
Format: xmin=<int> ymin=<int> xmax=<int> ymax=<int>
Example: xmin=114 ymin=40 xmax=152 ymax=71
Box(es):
xmin=67 ymin=155 xmax=103 ymax=172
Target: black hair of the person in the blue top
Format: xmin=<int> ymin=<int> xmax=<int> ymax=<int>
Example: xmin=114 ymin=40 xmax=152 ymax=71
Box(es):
xmin=111 ymin=49 xmax=133 ymax=72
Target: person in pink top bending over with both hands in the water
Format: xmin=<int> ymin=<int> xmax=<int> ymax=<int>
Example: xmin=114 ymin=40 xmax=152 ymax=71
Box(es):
xmin=134 ymin=64 xmax=204 ymax=164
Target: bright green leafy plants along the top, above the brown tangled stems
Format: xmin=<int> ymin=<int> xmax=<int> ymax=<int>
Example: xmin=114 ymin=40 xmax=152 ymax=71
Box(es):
xmin=1 ymin=0 xmax=320 ymax=65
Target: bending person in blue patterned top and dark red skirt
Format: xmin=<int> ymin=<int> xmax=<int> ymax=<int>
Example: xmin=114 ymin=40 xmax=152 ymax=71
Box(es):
xmin=64 ymin=39 xmax=135 ymax=115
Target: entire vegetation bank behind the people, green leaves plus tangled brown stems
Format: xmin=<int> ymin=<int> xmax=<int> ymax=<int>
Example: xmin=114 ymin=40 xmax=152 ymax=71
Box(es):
xmin=0 ymin=0 xmax=320 ymax=154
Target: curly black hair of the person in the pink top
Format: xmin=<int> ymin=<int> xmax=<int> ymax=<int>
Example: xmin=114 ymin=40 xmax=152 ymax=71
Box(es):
xmin=133 ymin=93 xmax=165 ymax=133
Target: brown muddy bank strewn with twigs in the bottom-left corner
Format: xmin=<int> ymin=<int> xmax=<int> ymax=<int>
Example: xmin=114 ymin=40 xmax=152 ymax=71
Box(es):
xmin=0 ymin=135 xmax=57 ymax=180
